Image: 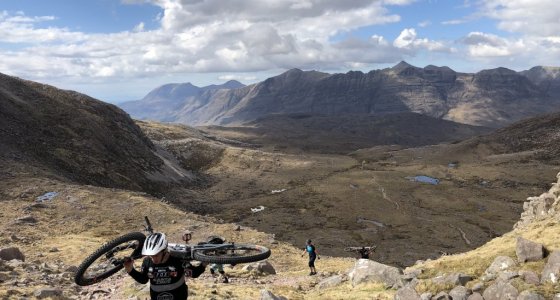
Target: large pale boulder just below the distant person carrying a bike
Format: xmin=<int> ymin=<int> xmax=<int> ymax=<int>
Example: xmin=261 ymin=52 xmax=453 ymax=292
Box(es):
xmin=348 ymin=259 xmax=403 ymax=287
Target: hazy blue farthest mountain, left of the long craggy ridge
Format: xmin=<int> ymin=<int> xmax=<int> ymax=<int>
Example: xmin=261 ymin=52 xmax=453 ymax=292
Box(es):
xmin=119 ymin=80 xmax=245 ymax=122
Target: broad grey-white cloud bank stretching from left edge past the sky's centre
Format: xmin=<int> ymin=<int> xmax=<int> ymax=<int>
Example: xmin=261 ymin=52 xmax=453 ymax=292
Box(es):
xmin=0 ymin=0 xmax=420 ymax=79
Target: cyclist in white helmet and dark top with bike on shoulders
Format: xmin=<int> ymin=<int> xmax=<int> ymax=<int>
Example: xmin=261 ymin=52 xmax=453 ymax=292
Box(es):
xmin=124 ymin=232 xmax=206 ymax=300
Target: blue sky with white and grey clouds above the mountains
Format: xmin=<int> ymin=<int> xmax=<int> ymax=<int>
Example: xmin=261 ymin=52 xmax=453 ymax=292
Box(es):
xmin=0 ymin=0 xmax=560 ymax=103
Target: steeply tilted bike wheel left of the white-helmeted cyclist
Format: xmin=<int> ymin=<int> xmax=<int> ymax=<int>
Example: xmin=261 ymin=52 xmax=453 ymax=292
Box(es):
xmin=74 ymin=232 xmax=146 ymax=286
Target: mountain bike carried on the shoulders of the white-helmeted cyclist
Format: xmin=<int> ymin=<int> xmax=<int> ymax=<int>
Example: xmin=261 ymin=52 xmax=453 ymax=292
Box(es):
xmin=74 ymin=217 xmax=270 ymax=286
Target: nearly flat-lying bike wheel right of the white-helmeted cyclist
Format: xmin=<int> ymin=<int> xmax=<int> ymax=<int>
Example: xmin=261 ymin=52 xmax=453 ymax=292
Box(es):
xmin=193 ymin=244 xmax=270 ymax=264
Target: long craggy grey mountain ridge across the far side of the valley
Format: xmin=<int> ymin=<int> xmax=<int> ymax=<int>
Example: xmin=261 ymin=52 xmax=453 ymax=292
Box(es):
xmin=123 ymin=62 xmax=560 ymax=128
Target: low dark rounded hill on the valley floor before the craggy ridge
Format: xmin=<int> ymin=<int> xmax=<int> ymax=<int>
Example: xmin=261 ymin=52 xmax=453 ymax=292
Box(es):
xmin=201 ymin=113 xmax=491 ymax=154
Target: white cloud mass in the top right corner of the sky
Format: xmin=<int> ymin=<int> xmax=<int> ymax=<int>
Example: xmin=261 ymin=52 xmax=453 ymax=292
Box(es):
xmin=450 ymin=0 xmax=560 ymax=69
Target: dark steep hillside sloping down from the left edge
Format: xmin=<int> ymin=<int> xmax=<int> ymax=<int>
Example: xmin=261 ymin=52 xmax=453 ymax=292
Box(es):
xmin=0 ymin=74 xmax=192 ymax=192
